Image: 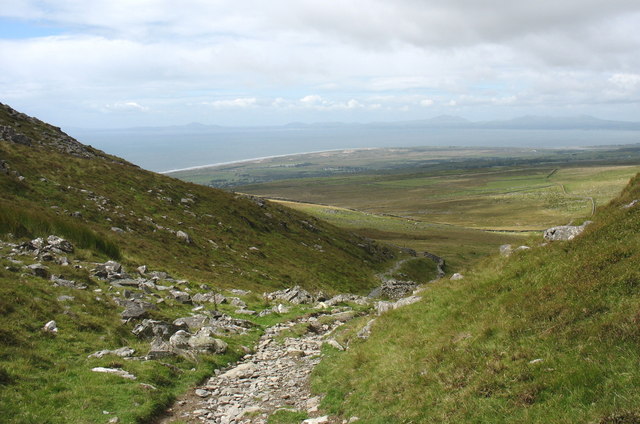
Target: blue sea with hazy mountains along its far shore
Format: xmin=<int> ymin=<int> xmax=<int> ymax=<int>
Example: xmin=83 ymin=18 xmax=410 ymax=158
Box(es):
xmin=66 ymin=115 xmax=640 ymax=171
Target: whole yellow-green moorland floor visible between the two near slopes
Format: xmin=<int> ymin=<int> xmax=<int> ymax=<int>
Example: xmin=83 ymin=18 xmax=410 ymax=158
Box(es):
xmin=238 ymin=164 xmax=640 ymax=270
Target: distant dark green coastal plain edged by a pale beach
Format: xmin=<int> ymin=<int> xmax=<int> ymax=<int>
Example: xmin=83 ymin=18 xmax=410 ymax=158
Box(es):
xmin=168 ymin=144 xmax=640 ymax=188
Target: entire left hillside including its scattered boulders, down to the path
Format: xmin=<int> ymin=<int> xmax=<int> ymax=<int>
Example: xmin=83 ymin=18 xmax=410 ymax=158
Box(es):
xmin=0 ymin=105 xmax=397 ymax=423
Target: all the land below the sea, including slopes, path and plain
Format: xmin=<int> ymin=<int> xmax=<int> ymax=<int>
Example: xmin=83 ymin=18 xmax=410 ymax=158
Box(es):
xmin=0 ymin=105 xmax=640 ymax=424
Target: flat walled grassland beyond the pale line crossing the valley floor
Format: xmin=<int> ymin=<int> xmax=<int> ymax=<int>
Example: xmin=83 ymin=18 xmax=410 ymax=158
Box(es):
xmin=240 ymin=165 xmax=640 ymax=230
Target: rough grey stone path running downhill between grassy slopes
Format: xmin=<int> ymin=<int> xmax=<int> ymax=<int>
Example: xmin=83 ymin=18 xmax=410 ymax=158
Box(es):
xmin=158 ymin=312 xmax=353 ymax=424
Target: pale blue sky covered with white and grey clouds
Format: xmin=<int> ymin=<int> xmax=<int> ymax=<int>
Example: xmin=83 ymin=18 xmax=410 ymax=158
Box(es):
xmin=0 ymin=0 xmax=640 ymax=128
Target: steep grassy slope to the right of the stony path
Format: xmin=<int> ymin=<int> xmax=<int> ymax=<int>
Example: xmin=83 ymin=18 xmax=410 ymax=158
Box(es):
xmin=314 ymin=176 xmax=640 ymax=424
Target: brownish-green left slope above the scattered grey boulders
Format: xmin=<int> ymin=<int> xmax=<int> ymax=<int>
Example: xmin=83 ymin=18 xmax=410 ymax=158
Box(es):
xmin=0 ymin=105 xmax=391 ymax=292
